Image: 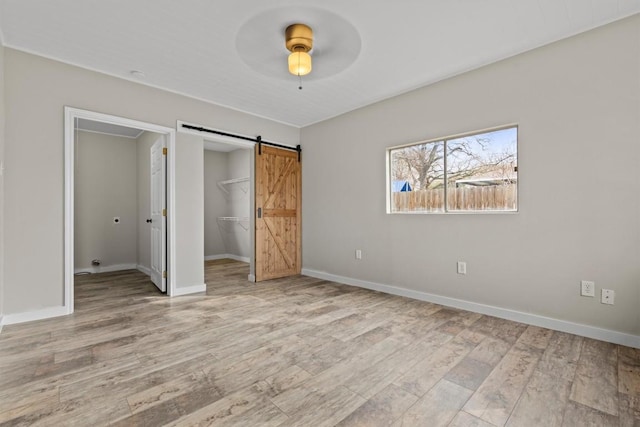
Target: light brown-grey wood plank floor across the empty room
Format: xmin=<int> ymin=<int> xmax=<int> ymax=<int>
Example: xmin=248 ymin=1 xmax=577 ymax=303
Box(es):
xmin=0 ymin=260 xmax=640 ymax=427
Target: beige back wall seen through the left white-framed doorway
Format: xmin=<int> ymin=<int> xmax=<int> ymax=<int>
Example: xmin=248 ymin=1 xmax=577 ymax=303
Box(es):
xmin=74 ymin=131 xmax=138 ymax=271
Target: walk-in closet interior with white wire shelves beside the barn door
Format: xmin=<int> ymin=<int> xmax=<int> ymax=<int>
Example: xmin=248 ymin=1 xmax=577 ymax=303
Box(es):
xmin=204 ymin=145 xmax=251 ymax=262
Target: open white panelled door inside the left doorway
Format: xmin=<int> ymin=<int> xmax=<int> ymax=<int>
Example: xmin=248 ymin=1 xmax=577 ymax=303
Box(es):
xmin=151 ymin=137 xmax=167 ymax=292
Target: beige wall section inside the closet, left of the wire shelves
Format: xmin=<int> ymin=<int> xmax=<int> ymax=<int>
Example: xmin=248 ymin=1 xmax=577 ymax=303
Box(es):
xmin=204 ymin=150 xmax=229 ymax=256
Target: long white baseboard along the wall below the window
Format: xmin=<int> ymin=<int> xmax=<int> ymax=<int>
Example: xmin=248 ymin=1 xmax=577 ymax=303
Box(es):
xmin=302 ymin=268 xmax=640 ymax=348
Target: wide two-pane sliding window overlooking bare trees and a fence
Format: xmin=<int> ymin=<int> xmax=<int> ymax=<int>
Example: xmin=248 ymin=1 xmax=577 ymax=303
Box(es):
xmin=387 ymin=126 xmax=518 ymax=213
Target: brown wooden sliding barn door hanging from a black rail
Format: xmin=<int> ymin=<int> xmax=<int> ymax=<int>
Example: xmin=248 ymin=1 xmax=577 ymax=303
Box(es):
xmin=255 ymin=145 xmax=302 ymax=282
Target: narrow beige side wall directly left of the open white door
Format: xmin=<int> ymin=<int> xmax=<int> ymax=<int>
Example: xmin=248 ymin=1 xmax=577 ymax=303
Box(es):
xmin=136 ymin=132 xmax=162 ymax=270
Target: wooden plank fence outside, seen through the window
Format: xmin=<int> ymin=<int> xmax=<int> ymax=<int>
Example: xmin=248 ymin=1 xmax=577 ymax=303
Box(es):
xmin=392 ymin=184 xmax=518 ymax=212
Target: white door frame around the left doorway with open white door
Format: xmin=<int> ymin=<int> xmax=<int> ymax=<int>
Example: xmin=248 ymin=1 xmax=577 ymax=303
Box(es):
xmin=63 ymin=106 xmax=176 ymax=314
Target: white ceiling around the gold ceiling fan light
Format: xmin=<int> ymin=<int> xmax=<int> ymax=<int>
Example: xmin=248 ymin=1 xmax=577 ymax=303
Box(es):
xmin=0 ymin=0 xmax=640 ymax=127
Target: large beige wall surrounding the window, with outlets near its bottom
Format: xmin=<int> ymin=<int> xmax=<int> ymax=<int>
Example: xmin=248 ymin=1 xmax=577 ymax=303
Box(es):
xmin=301 ymin=15 xmax=640 ymax=336
